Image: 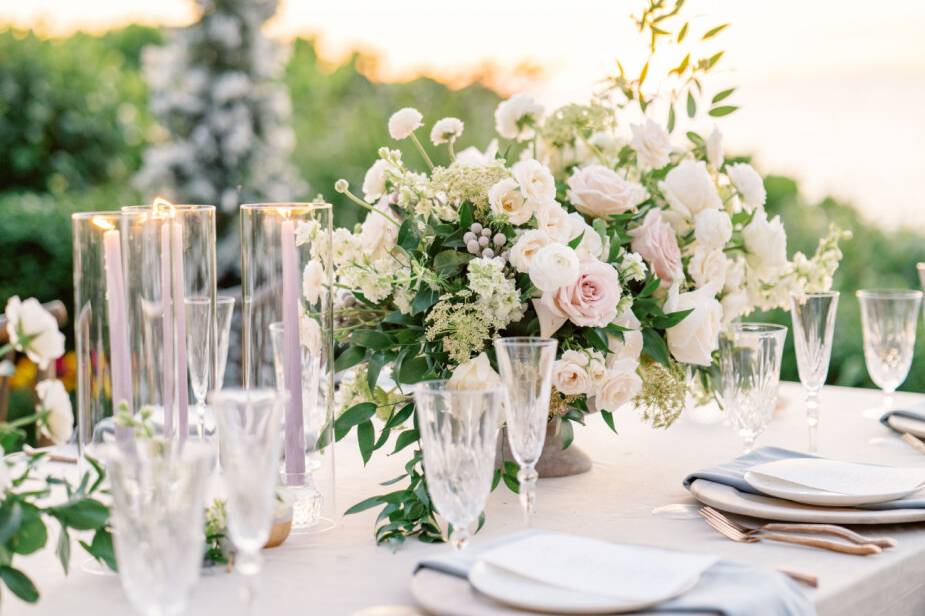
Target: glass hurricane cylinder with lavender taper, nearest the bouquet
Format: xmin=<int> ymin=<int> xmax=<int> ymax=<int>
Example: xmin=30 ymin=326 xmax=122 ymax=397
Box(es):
xmin=241 ymin=202 xmax=337 ymax=533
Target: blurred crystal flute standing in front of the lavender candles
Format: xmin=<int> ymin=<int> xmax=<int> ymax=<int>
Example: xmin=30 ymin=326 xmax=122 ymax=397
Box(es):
xmin=209 ymin=389 xmax=285 ymax=608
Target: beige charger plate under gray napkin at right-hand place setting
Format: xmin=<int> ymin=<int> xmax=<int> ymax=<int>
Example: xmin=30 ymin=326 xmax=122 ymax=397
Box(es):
xmin=690 ymin=479 xmax=925 ymax=525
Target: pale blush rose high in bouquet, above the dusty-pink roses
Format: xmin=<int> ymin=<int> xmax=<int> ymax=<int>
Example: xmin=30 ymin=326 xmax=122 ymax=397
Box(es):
xmin=568 ymin=165 xmax=649 ymax=218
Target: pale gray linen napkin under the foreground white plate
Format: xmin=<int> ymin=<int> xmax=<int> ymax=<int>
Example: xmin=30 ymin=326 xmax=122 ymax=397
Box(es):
xmin=415 ymin=531 xmax=816 ymax=616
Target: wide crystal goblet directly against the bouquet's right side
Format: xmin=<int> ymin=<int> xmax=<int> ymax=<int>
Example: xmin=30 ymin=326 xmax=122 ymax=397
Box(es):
xmin=719 ymin=323 xmax=787 ymax=453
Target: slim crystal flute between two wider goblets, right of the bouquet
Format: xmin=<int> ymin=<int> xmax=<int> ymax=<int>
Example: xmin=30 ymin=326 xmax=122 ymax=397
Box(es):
xmin=790 ymin=291 xmax=838 ymax=453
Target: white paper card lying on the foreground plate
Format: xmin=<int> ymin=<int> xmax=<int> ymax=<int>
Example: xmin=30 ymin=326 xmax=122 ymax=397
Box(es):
xmin=479 ymin=533 xmax=718 ymax=602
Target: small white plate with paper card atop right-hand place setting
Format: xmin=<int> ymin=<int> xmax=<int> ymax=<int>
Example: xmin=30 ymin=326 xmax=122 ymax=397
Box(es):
xmin=748 ymin=458 xmax=925 ymax=496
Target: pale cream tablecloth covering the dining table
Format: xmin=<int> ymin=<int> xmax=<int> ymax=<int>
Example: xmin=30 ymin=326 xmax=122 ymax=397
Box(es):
xmin=3 ymin=384 xmax=925 ymax=616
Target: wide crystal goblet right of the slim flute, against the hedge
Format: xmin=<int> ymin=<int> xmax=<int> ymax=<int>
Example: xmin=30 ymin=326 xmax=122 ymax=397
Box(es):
xmin=857 ymin=289 xmax=922 ymax=419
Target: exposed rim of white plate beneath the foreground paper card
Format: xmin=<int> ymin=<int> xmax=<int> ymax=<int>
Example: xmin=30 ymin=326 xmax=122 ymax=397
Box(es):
xmin=469 ymin=561 xmax=699 ymax=614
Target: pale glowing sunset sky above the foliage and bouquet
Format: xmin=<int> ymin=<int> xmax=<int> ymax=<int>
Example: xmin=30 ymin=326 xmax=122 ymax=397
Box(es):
xmin=0 ymin=0 xmax=925 ymax=227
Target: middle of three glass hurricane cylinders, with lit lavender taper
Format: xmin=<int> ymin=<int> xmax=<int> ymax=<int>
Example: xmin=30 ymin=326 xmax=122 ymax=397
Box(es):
xmin=122 ymin=200 xmax=216 ymax=440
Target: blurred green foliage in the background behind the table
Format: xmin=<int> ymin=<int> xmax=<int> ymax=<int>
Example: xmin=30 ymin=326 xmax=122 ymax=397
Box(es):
xmin=0 ymin=26 xmax=925 ymax=398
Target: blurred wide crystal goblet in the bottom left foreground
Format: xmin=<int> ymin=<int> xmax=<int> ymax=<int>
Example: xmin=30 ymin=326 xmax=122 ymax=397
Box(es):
xmin=104 ymin=443 xmax=214 ymax=616
